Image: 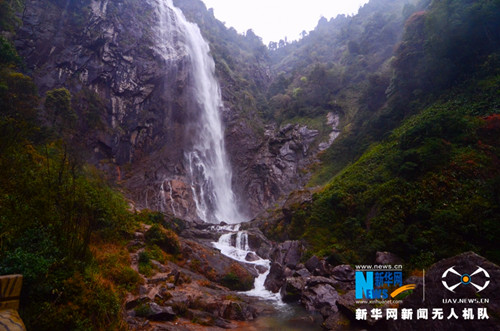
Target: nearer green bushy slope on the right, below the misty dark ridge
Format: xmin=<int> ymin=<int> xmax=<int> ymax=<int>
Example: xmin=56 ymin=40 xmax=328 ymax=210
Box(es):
xmin=262 ymin=72 xmax=500 ymax=267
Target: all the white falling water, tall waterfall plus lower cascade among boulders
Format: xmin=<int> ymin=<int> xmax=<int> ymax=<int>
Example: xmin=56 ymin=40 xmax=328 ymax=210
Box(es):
xmin=158 ymin=0 xmax=281 ymax=302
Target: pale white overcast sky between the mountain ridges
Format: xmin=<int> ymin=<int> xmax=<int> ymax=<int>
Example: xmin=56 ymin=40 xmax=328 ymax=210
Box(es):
xmin=202 ymin=0 xmax=368 ymax=45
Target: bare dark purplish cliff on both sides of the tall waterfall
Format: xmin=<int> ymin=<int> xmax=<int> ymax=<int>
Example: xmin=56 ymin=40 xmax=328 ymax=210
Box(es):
xmin=16 ymin=0 xmax=316 ymax=219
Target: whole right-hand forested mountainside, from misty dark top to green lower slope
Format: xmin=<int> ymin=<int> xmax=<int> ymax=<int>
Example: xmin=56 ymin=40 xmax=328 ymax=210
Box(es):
xmin=267 ymin=1 xmax=500 ymax=266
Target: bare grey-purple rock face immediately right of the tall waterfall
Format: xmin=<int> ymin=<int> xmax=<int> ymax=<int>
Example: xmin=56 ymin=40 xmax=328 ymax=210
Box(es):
xmin=227 ymin=122 xmax=318 ymax=214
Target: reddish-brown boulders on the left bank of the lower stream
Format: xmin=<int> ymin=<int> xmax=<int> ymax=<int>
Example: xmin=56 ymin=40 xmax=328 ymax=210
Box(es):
xmin=125 ymin=225 xmax=274 ymax=330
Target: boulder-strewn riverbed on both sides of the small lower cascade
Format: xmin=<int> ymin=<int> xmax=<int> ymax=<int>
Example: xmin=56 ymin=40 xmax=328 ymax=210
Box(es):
xmin=120 ymin=217 xmax=500 ymax=330
